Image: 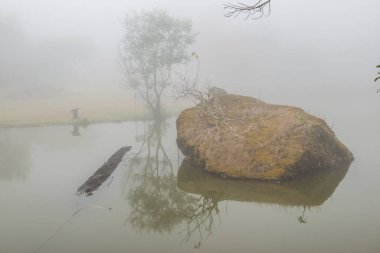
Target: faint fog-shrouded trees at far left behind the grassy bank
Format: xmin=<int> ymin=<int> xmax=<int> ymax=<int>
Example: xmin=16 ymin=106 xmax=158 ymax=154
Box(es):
xmin=0 ymin=13 xmax=94 ymax=94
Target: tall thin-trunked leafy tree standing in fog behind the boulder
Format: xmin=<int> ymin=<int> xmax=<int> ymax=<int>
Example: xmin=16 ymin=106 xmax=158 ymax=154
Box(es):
xmin=120 ymin=10 xmax=195 ymax=116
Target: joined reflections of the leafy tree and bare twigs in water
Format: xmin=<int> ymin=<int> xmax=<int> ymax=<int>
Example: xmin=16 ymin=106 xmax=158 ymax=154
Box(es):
xmin=125 ymin=115 xmax=219 ymax=247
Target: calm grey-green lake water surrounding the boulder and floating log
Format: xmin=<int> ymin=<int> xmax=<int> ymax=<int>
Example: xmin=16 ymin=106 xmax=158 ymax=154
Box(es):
xmin=0 ymin=89 xmax=380 ymax=253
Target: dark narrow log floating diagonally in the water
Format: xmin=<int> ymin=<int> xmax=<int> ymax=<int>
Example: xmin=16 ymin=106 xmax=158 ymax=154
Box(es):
xmin=77 ymin=146 xmax=131 ymax=196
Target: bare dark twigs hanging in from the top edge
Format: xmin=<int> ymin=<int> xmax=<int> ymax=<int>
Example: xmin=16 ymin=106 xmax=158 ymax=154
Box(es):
xmin=224 ymin=0 xmax=271 ymax=19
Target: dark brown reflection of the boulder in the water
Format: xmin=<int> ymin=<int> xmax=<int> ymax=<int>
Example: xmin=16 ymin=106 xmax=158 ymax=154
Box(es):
xmin=177 ymin=160 xmax=348 ymax=207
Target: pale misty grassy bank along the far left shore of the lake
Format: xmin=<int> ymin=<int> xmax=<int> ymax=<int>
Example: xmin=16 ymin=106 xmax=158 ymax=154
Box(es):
xmin=0 ymin=92 xmax=186 ymax=128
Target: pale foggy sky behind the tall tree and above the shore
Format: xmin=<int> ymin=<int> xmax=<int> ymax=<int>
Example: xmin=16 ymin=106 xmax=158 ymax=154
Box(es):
xmin=0 ymin=0 xmax=380 ymax=102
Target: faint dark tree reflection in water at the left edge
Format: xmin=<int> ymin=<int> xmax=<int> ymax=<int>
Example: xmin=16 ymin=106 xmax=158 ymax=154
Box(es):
xmin=0 ymin=140 xmax=31 ymax=180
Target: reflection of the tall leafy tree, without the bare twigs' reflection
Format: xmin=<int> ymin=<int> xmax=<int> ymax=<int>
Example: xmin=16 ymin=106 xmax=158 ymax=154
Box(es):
xmin=127 ymin=120 xmax=186 ymax=232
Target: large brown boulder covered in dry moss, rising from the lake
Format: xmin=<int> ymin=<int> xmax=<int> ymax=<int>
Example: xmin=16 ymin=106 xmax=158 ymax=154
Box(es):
xmin=177 ymin=94 xmax=353 ymax=181
